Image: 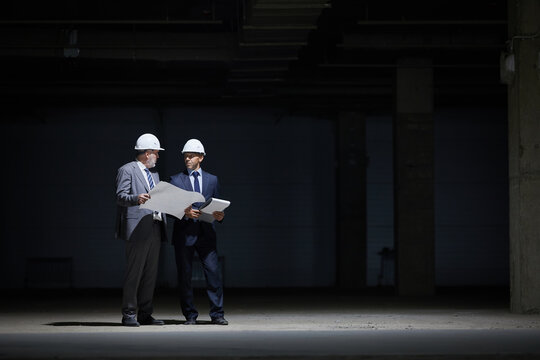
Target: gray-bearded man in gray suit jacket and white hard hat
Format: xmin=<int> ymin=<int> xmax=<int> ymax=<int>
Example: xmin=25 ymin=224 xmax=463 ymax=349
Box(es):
xmin=116 ymin=134 xmax=166 ymax=326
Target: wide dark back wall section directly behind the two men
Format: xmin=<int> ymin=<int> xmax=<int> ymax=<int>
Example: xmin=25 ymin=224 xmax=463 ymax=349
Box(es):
xmin=1 ymin=107 xmax=335 ymax=287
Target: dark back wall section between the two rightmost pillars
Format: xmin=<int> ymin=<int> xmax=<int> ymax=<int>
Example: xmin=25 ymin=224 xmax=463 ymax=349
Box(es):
xmin=435 ymin=108 xmax=509 ymax=286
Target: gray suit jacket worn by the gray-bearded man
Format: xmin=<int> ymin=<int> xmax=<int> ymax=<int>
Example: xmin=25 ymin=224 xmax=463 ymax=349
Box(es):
xmin=116 ymin=161 xmax=167 ymax=241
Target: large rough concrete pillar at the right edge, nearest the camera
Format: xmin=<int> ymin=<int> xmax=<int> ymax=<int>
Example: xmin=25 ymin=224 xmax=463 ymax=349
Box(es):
xmin=508 ymin=0 xmax=540 ymax=313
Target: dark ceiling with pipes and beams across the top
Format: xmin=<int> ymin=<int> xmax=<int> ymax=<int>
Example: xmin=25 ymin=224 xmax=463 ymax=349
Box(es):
xmin=0 ymin=0 xmax=507 ymax=110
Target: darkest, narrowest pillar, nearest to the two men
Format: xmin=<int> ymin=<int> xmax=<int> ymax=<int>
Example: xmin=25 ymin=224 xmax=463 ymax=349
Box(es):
xmin=336 ymin=112 xmax=367 ymax=289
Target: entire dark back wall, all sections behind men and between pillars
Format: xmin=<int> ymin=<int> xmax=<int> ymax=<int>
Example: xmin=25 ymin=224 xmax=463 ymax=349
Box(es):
xmin=0 ymin=103 xmax=508 ymax=288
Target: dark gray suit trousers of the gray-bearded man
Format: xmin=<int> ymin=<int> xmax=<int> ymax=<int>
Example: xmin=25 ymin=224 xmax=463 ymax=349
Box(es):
xmin=122 ymin=215 xmax=161 ymax=318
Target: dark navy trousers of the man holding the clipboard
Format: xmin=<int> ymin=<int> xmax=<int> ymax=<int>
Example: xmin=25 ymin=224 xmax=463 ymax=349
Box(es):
xmin=174 ymin=239 xmax=224 ymax=319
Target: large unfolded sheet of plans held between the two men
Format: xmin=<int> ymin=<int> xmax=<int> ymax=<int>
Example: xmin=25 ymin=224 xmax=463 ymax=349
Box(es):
xmin=140 ymin=181 xmax=205 ymax=219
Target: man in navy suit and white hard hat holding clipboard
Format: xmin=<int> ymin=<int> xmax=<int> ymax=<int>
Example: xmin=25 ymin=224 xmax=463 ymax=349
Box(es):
xmin=170 ymin=139 xmax=228 ymax=325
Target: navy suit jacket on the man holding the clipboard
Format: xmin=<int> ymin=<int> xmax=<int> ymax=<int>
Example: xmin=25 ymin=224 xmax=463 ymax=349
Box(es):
xmin=170 ymin=169 xmax=219 ymax=246
